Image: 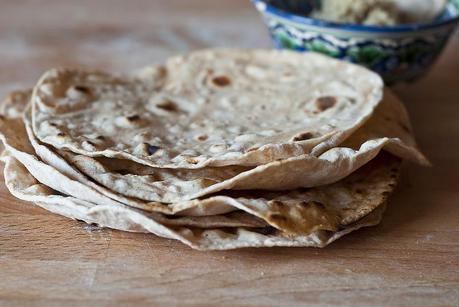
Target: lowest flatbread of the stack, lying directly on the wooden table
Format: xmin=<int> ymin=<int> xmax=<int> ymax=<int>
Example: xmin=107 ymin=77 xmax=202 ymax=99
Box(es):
xmin=2 ymin=154 xmax=385 ymax=250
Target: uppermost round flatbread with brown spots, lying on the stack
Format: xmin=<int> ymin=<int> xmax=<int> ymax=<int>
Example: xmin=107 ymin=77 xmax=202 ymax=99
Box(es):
xmin=32 ymin=50 xmax=383 ymax=168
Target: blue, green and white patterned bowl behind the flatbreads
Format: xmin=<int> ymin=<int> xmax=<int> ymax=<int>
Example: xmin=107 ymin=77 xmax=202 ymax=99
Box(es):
xmin=252 ymin=0 xmax=459 ymax=84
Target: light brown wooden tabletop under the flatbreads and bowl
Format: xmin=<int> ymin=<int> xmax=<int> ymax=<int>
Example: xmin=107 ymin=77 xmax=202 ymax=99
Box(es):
xmin=0 ymin=0 xmax=459 ymax=306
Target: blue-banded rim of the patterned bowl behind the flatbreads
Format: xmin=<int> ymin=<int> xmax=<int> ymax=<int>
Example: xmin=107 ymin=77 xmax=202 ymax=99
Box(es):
xmin=251 ymin=0 xmax=459 ymax=33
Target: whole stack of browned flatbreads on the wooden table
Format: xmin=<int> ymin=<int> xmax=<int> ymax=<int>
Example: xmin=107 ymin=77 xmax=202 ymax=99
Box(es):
xmin=0 ymin=50 xmax=428 ymax=250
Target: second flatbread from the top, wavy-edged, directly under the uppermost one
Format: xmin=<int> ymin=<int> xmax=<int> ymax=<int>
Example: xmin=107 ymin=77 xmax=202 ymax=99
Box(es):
xmin=21 ymin=91 xmax=427 ymax=209
